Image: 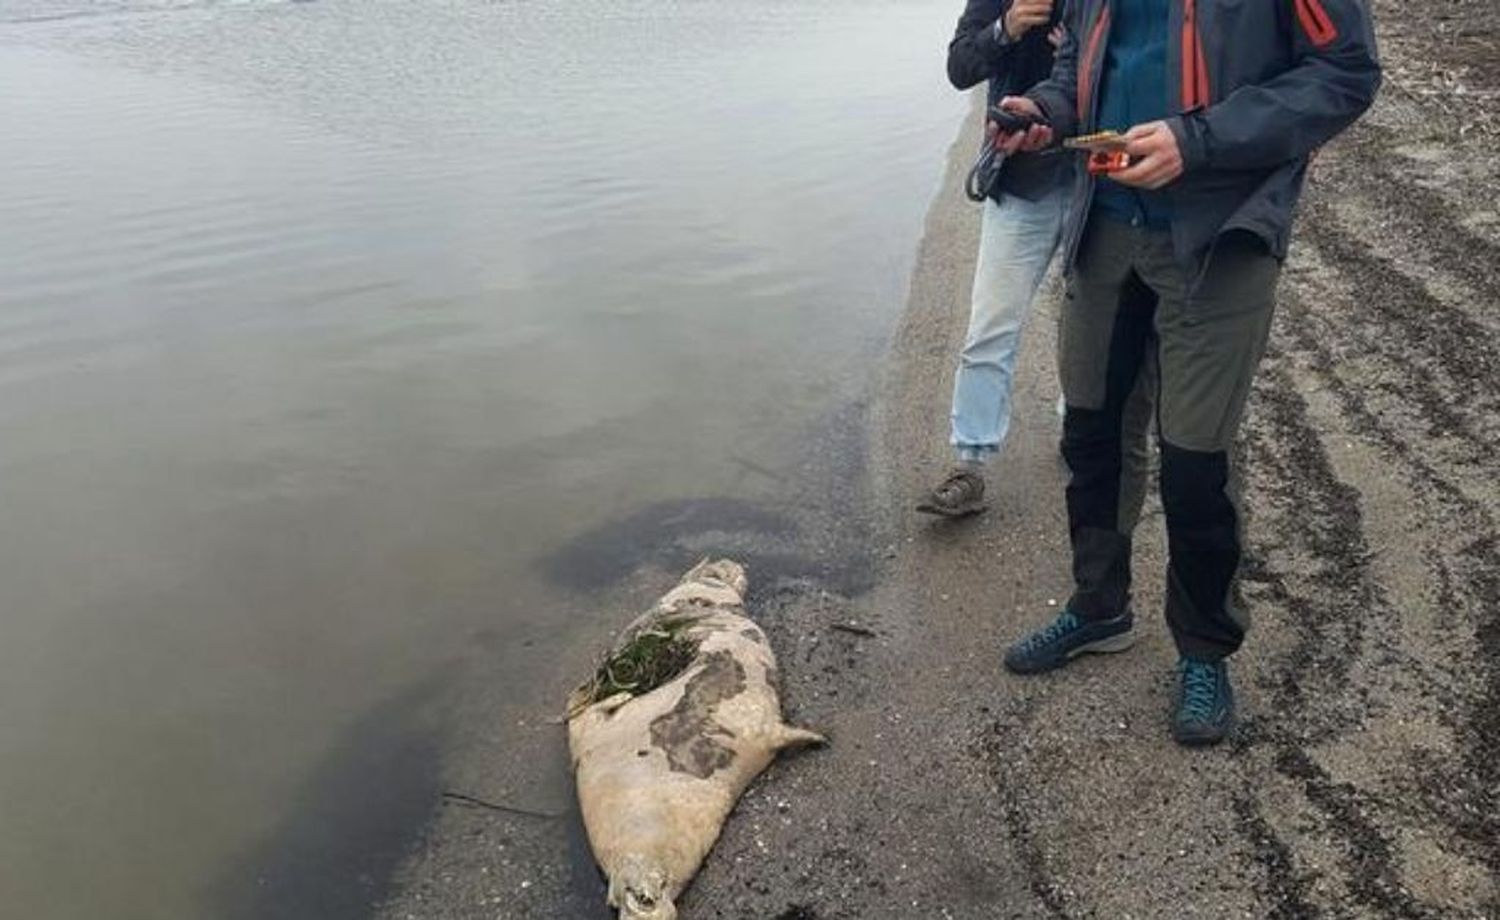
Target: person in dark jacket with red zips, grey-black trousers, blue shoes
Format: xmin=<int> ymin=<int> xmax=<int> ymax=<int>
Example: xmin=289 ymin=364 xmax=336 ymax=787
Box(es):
xmin=999 ymin=0 xmax=1380 ymax=744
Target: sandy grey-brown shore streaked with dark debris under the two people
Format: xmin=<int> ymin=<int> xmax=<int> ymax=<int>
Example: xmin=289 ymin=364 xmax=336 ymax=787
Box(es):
xmin=383 ymin=0 xmax=1500 ymax=920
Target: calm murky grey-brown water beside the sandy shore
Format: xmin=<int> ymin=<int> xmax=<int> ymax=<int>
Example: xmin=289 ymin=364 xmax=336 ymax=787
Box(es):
xmin=0 ymin=0 xmax=965 ymax=920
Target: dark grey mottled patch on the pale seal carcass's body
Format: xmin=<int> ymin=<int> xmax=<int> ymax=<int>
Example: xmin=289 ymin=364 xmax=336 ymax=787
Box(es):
xmin=651 ymin=650 xmax=746 ymax=779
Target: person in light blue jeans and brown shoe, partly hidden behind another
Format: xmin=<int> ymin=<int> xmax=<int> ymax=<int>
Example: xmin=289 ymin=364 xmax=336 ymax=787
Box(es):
xmin=917 ymin=0 xmax=1152 ymax=518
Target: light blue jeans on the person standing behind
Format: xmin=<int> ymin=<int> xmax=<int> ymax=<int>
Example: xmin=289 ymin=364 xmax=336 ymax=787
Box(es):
xmin=953 ymin=186 xmax=1068 ymax=459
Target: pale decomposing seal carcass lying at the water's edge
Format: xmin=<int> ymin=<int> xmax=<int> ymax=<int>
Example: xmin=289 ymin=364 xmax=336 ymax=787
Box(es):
xmin=569 ymin=561 xmax=824 ymax=920
